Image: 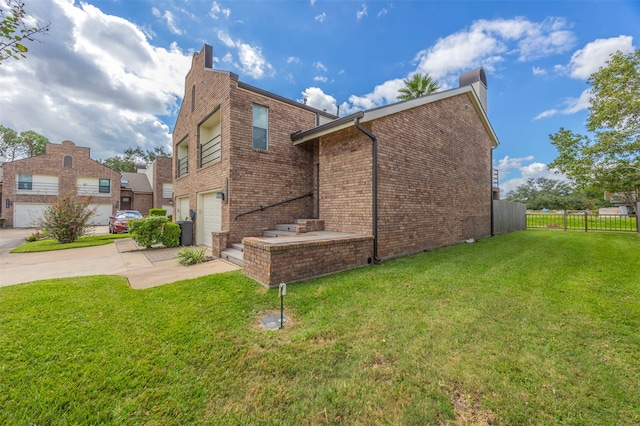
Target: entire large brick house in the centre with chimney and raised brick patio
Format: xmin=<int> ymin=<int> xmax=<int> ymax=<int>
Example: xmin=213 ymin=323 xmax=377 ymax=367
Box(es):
xmin=173 ymin=45 xmax=498 ymax=286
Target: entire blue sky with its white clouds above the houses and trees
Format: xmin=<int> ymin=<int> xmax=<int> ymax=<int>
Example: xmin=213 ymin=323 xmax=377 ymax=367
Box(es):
xmin=0 ymin=0 xmax=640 ymax=192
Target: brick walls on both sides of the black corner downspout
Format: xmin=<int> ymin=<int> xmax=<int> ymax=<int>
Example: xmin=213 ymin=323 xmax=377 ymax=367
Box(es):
xmin=319 ymin=94 xmax=491 ymax=258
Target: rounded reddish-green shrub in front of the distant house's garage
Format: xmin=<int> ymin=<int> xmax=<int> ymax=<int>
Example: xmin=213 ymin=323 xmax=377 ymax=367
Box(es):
xmin=38 ymin=194 xmax=96 ymax=244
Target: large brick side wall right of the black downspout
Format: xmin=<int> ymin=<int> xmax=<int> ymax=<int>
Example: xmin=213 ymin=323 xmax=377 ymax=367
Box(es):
xmin=372 ymin=94 xmax=492 ymax=257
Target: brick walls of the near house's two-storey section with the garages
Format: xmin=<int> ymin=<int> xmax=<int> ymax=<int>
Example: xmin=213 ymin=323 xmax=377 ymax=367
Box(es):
xmin=173 ymin=45 xmax=316 ymax=242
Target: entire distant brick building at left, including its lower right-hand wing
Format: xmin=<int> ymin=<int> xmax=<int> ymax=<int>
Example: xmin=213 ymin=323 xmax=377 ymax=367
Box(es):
xmin=0 ymin=141 xmax=173 ymax=228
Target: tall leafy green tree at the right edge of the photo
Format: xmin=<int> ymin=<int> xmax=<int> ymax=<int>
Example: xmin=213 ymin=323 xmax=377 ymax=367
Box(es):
xmin=549 ymin=50 xmax=640 ymax=205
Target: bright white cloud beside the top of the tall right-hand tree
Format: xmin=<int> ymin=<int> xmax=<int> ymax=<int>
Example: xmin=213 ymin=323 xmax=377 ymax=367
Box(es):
xmin=557 ymin=35 xmax=634 ymax=80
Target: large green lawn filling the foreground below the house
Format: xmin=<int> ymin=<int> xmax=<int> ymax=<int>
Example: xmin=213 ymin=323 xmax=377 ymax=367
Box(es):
xmin=0 ymin=230 xmax=640 ymax=425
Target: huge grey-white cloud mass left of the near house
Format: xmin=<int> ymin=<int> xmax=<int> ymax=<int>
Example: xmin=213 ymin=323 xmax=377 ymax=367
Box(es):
xmin=0 ymin=0 xmax=191 ymax=159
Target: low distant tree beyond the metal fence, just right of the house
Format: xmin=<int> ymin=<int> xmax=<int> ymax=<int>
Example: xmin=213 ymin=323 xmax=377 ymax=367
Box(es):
xmin=505 ymin=177 xmax=586 ymax=210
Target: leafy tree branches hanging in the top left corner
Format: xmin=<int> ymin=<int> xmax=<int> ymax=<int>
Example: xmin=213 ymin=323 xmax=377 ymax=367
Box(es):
xmin=0 ymin=0 xmax=51 ymax=64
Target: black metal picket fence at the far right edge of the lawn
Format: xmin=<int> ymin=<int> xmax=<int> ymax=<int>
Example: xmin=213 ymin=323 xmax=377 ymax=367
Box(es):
xmin=527 ymin=212 xmax=640 ymax=232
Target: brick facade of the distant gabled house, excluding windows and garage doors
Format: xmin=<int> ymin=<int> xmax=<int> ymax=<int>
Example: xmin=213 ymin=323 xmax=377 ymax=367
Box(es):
xmin=2 ymin=141 xmax=120 ymax=227
